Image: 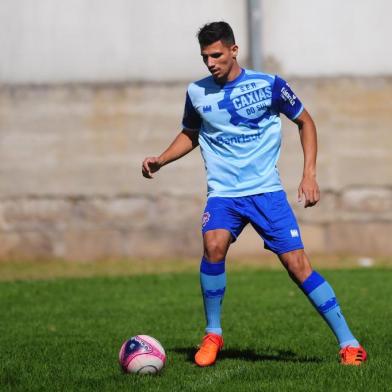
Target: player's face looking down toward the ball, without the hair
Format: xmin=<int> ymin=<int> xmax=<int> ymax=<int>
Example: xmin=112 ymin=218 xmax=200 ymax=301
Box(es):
xmin=201 ymin=41 xmax=238 ymax=81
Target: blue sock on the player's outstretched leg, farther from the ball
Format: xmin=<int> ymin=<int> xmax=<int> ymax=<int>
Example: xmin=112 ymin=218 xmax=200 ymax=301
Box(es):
xmin=300 ymin=271 xmax=359 ymax=348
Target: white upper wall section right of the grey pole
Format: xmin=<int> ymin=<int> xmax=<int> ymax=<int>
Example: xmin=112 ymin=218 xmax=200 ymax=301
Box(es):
xmin=263 ymin=0 xmax=392 ymax=76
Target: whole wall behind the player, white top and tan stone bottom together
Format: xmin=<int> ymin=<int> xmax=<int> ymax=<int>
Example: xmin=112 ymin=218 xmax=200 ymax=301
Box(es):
xmin=0 ymin=0 xmax=392 ymax=260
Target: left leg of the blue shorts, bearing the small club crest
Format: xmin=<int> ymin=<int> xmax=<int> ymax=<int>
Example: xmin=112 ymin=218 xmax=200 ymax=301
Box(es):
xmin=202 ymin=197 xmax=248 ymax=242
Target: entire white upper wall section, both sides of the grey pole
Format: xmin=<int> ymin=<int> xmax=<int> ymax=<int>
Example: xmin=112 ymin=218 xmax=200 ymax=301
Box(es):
xmin=0 ymin=0 xmax=392 ymax=84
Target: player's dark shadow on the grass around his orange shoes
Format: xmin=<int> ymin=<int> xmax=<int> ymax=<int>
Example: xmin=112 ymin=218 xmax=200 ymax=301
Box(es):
xmin=170 ymin=347 xmax=322 ymax=363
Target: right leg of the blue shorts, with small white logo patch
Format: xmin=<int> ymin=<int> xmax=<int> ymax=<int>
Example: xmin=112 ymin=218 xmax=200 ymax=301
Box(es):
xmin=251 ymin=191 xmax=304 ymax=255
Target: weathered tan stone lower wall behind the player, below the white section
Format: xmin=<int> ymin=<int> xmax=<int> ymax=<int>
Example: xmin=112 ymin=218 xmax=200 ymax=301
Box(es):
xmin=0 ymin=78 xmax=392 ymax=260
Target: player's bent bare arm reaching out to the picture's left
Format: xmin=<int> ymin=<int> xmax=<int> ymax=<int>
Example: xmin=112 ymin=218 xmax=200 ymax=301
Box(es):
xmin=142 ymin=129 xmax=199 ymax=178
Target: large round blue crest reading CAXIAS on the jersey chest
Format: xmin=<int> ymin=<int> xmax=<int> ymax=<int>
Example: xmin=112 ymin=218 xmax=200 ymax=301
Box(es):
xmin=218 ymin=75 xmax=272 ymax=129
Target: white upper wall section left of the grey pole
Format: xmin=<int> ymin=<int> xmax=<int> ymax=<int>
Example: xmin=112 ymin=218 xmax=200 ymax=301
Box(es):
xmin=0 ymin=0 xmax=246 ymax=83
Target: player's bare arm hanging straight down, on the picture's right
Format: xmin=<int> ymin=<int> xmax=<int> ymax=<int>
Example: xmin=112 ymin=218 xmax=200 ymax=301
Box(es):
xmin=292 ymin=109 xmax=320 ymax=208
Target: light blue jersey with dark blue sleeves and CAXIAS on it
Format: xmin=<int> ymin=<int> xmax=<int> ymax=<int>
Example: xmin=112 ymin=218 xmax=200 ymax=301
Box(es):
xmin=183 ymin=69 xmax=303 ymax=197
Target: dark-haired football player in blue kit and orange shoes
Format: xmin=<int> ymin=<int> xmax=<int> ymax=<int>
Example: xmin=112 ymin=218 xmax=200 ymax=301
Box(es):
xmin=142 ymin=22 xmax=366 ymax=366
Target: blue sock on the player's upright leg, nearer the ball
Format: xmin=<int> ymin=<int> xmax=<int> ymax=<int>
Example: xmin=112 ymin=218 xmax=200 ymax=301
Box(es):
xmin=200 ymin=257 xmax=226 ymax=335
